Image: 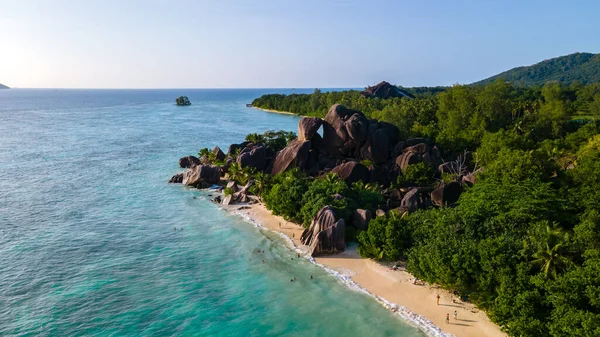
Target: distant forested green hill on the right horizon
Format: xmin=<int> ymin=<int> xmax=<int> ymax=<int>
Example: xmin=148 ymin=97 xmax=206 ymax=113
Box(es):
xmin=473 ymin=53 xmax=600 ymax=86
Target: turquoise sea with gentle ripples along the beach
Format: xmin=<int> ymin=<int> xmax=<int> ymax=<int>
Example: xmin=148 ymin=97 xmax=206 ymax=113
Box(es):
xmin=0 ymin=89 xmax=422 ymax=336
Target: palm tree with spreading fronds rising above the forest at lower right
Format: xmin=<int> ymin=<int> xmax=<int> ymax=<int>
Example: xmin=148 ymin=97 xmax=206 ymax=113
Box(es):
xmin=531 ymin=225 xmax=570 ymax=279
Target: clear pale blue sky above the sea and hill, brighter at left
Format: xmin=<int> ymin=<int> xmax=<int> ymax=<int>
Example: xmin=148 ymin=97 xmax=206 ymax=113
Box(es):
xmin=0 ymin=0 xmax=600 ymax=88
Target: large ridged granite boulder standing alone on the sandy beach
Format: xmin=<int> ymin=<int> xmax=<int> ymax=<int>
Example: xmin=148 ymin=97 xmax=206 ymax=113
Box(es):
xmin=300 ymin=206 xmax=346 ymax=256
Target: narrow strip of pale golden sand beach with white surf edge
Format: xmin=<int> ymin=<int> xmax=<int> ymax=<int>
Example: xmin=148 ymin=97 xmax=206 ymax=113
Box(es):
xmin=221 ymin=203 xmax=507 ymax=337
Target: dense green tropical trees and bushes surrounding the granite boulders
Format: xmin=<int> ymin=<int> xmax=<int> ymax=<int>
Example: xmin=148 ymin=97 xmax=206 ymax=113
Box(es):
xmin=255 ymin=80 xmax=600 ymax=336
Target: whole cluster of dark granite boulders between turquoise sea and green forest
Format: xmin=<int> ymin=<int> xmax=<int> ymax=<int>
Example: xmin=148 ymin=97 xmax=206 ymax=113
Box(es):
xmin=170 ymin=104 xmax=476 ymax=255
